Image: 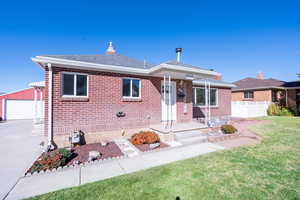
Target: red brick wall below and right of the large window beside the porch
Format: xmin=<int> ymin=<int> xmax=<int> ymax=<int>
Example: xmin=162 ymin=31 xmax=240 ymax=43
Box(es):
xmin=193 ymin=88 xmax=231 ymax=118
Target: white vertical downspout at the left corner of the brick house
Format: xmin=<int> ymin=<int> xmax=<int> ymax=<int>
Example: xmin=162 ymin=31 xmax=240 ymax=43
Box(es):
xmin=47 ymin=63 xmax=54 ymax=151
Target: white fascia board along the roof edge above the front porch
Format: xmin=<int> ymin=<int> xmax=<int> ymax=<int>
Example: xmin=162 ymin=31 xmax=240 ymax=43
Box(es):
xmin=149 ymin=63 xmax=221 ymax=76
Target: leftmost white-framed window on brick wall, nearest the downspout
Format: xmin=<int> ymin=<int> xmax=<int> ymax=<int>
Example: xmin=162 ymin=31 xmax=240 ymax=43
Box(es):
xmin=61 ymin=72 xmax=88 ymax=97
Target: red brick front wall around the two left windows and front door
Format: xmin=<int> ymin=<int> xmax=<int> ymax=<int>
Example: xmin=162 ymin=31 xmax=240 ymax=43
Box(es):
xmin=45 ymin=67 xmax=192 ymax=135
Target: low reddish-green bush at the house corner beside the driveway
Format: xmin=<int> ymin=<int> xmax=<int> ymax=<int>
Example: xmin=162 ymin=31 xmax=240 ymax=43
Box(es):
xmin=28 ymin=149 xmax=72 ymax=173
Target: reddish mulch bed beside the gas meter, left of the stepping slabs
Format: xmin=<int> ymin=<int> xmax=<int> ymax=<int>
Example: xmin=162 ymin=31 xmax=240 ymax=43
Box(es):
xmin=68 ymin=142 xmax=123 ymax=165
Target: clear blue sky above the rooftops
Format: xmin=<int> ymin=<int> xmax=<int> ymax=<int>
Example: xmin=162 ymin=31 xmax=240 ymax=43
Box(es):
xmin=0 ymin=0 xmax=300 ymax=92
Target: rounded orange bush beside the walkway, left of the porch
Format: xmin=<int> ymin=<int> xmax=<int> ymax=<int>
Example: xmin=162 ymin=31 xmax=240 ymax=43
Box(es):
xmin=130 ymin=131 xmax=160 ymax=145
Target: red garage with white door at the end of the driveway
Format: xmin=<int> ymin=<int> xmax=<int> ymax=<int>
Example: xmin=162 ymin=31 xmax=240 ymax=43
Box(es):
xmin=0 ymin=82 xmax=45 ymax=120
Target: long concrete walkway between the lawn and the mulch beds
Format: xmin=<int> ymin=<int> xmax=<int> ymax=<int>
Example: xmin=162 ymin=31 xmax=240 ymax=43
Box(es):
xmin=6 ymin=143 xmax=224 ymax=200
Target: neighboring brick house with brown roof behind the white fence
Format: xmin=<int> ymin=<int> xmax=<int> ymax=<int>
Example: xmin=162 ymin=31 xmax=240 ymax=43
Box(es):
xmin=232 ymin=73 xmax=300 ymax=111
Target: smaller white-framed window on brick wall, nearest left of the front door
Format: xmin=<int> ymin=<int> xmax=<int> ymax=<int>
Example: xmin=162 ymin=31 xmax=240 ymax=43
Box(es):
xmin=122 ymin=78 xmax=141 ymax=98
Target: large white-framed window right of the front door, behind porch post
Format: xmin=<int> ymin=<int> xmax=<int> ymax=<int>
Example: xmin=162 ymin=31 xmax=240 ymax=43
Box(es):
xmin=193 ymin=87 xmax=218 ymax=106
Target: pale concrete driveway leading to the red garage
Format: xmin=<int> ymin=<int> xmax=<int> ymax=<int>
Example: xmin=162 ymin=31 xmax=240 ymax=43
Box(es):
xmin=0 ymin=120 xmax=43 ymax=199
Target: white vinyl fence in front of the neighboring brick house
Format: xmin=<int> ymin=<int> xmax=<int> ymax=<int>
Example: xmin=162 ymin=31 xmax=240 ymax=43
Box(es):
xmin=231 ymin=101 xmax=271 ymax=118
